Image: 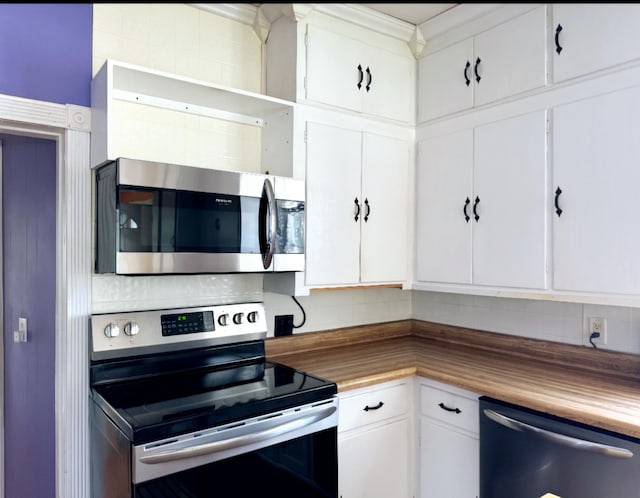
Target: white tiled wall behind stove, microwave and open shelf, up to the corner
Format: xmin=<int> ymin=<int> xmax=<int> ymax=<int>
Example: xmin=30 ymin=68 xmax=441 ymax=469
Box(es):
xmin=92 ymin=4 xmax=411 ymax=335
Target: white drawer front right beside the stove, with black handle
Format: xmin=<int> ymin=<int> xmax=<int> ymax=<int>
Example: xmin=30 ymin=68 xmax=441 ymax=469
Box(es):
xmin=338 ymin=384 xmax=407 ymax=432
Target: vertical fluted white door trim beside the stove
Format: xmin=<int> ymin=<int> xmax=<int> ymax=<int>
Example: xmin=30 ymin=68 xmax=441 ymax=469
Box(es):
xmin=56 ymin=130 xmax=91 ymax=498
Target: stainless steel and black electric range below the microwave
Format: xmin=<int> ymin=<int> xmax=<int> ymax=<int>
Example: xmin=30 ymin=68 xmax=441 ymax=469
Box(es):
xmin=90 ymin=303 xmax=338 ymax=498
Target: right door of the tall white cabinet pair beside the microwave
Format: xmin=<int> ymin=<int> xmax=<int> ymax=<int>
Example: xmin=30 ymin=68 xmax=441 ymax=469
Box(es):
xmin=360 ymin=133 xmax=409 ymax=283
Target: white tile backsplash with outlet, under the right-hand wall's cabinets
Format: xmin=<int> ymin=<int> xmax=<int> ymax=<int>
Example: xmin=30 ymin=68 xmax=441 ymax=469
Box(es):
xmin=412 ymin=291 xmax=640 ymax=354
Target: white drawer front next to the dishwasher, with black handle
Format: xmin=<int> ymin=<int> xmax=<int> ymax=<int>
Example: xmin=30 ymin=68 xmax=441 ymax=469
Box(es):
xmin=420 ymin=385 xmax=479 ymax=434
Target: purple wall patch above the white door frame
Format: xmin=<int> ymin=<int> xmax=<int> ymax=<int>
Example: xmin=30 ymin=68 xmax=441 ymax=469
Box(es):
xmin=0 ymin=3 xmax=93 ymax=107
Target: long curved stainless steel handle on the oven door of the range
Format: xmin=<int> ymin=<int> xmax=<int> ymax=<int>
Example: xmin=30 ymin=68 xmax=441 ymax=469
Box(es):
xmin=139 ymin=405 xmax=337 ymax=464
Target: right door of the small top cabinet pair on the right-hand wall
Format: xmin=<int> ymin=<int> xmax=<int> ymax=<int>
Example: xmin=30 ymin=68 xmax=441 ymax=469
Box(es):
xmin=473 ymin=6 xmax=547 ymax=106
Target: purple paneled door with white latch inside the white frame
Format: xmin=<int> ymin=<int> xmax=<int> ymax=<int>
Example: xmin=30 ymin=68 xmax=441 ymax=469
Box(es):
xmin=0 ymin=135 xmax=56 ymax=498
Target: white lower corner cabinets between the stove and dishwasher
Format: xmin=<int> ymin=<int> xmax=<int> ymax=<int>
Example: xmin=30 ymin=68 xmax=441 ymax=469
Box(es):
xmin=338 ymin=377 xmax=480 ymax=498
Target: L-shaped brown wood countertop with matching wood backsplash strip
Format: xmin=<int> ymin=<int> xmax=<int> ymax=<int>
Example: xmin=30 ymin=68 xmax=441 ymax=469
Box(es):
xmin=265 ymin=320 xmax=640 ymax=438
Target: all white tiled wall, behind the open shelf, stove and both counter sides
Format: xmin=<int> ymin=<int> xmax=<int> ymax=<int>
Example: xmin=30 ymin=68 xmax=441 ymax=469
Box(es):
xmin=92 ymin=4 xmax=640 ymax=354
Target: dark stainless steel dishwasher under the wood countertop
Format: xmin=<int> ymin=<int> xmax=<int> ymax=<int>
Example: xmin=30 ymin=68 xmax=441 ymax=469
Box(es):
xmin=479 ymin=397 xmax=640 ymax=498
